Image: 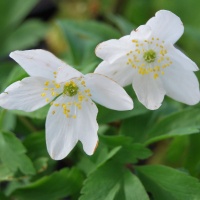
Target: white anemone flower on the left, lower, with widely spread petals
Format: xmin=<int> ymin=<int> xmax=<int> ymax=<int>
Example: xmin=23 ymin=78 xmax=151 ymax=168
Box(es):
xmin=0 ymin=50 xmax=133 ymax=160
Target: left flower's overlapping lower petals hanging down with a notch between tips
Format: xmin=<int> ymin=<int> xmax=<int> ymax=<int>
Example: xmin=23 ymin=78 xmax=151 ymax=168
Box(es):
xmin=46 ymin=96 xmax=98 ymax=160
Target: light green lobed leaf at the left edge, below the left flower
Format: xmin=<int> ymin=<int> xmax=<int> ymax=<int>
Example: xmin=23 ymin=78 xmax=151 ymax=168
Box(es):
xmin=0 ymin=132 xmax=35 ymax=175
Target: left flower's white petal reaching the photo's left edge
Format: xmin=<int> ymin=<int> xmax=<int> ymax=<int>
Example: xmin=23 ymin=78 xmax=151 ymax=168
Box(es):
xmin=0 ymin=77 xmax=59 ymax=112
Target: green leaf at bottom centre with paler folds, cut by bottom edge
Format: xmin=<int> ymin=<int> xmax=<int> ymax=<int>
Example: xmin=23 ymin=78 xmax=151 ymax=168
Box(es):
xmin=79 ymin=162 xmax=148 ymax=200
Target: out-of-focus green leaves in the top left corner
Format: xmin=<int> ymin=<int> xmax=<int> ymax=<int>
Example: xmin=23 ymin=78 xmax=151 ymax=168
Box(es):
xmin=0 ymin=0 xmax=47 ymax=56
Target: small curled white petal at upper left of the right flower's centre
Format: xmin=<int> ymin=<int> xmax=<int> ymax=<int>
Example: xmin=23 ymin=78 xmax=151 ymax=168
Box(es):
xmin=131 ymin=25 xmax=152 ymax=41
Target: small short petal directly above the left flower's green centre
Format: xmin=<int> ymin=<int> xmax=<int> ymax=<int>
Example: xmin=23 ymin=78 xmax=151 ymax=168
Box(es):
xmin=56 ymin=65 xmax=83 ymax=83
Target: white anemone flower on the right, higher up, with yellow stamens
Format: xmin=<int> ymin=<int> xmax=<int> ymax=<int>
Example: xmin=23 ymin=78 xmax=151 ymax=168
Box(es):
xmin=95 ymin=10 xmax=200 ymax=110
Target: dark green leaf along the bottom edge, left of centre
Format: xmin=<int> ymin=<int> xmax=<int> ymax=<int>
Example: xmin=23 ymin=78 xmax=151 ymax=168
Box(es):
xmin=11 ymin=168 xmax=83 ymax=200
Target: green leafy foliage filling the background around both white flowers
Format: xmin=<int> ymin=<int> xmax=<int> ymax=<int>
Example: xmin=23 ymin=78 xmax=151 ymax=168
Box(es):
xmin=0 ymin=0 xmax=200 ymax=200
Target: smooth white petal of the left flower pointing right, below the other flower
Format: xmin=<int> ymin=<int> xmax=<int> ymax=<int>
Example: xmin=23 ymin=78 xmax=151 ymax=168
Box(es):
xmin=85 ymin=74 xmax=133 ymax=110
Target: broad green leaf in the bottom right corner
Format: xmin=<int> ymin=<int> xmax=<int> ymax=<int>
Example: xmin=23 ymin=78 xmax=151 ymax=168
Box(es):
xmin=136 ymin=165 xmax=200 ymax=200
